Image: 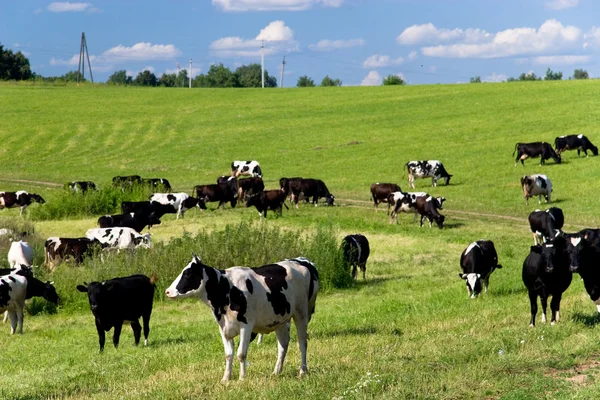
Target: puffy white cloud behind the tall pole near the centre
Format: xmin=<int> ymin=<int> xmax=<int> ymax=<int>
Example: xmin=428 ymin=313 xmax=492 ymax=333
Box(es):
xmin=210 ymin=21 xmax=298 ymax=57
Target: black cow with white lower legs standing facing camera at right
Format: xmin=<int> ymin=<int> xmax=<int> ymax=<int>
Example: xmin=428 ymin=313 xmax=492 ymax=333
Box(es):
xmin=522 ymin=237 xmax=573 ymax=328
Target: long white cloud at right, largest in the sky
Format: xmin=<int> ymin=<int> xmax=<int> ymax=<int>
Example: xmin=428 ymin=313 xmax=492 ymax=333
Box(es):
xmin=421 ymin=19 xmax=582 ymax=58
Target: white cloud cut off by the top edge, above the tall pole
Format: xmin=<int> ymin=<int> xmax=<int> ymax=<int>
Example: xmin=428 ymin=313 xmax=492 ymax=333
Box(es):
xmin=212 ymin=0 xmax=344 ymax=11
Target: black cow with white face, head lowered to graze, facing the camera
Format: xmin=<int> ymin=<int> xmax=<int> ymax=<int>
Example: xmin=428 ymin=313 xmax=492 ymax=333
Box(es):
xmin=458 ymin=240 xmax=502 ymax=299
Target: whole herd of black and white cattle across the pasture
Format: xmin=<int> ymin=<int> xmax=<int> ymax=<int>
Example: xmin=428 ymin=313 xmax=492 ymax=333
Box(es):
xmin=0 ymin=135 xmax=600 ymax=381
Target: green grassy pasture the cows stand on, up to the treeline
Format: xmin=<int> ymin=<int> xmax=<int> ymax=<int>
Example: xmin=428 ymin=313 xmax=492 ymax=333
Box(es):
xmin=0 ymin=81 xmax=600 ymax=399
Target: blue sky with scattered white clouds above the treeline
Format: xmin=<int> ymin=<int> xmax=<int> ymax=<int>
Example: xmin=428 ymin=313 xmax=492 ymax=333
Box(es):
xmin=0 ymin=0 xmax=600 ymax=87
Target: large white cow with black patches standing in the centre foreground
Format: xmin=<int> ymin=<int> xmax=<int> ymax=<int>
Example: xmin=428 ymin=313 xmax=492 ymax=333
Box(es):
xmin=165 ymin=254 xmax=319 ymax=382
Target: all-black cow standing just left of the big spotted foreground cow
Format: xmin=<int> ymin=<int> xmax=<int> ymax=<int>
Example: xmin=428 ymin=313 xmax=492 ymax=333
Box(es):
xmin=77 ymin=275 xmax=156 ymax=352
